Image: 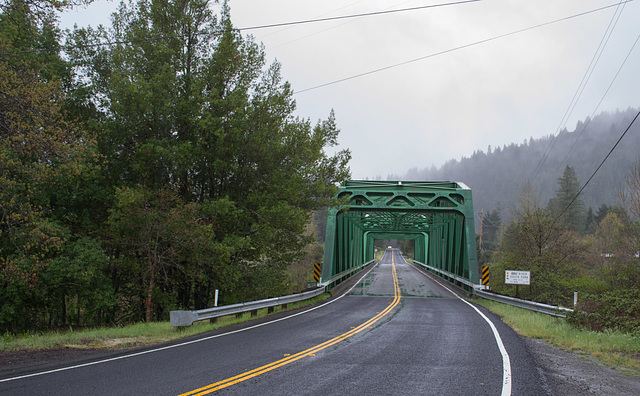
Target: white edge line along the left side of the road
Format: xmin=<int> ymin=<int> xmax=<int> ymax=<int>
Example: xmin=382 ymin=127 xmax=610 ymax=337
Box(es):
xmin=0 ymin=258 xmax=375 ymax=383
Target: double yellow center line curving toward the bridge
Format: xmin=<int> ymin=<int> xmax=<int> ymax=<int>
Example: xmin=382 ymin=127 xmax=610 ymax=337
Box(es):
xmin=180 ymin=252 xmax=400 ymax=396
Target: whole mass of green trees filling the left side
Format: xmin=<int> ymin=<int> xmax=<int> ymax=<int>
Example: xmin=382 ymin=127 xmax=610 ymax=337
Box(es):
xmin=0 ymin=0 xmax=350 ymax=332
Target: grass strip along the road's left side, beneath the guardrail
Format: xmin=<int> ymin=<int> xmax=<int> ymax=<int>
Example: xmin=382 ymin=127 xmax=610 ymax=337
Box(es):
xmin=0 ymin=293 xmax=329 ymax=352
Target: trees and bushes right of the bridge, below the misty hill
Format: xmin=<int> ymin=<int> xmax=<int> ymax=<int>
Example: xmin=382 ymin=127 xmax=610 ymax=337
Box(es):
xmin=478 ymin=163 xmax=640 ymax=346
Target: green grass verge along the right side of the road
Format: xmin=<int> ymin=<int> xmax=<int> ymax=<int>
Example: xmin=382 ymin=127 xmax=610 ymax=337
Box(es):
xmin=473 ymin=298 xmax=640 ymax=375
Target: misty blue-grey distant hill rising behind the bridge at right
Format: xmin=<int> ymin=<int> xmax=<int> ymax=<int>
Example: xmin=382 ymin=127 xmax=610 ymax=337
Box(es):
xmin=402 ymin=108 xmax=640 ymax=217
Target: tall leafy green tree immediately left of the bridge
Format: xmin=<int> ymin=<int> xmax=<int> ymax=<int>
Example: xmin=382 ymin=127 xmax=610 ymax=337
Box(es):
xmin=70 ymin=0 xmax=350 ymax=320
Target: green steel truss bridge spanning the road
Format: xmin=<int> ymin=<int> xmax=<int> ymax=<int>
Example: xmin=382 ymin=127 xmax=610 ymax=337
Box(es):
xmin=322 ymin=180 xmax=479 ymax=288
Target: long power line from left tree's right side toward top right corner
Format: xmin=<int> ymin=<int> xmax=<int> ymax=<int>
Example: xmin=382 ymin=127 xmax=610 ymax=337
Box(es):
xmin=294 ymin=0 xmax=634 ymax=95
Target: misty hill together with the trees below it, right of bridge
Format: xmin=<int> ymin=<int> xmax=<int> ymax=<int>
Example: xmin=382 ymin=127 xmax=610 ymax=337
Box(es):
xmin=406 ymin=109 xmax=640 ymax=336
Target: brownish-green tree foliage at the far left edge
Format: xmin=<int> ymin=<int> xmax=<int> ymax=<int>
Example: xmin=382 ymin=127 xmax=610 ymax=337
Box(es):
xmin=0 ymin=0 xmax=102 ymax=330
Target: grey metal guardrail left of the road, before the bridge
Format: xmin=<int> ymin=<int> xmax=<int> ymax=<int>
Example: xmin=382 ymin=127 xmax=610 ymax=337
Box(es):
xmin=169 ymin=286 xmax=325 ymax=327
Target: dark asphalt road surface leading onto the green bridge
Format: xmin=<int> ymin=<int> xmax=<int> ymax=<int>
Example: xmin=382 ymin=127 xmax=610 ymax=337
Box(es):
xmin=0 ymin=250 xmax=551 ymax=395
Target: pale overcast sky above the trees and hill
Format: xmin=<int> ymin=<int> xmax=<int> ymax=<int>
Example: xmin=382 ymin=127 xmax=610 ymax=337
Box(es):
xmin=62 ymin=0 xmax=640 ymax=179
